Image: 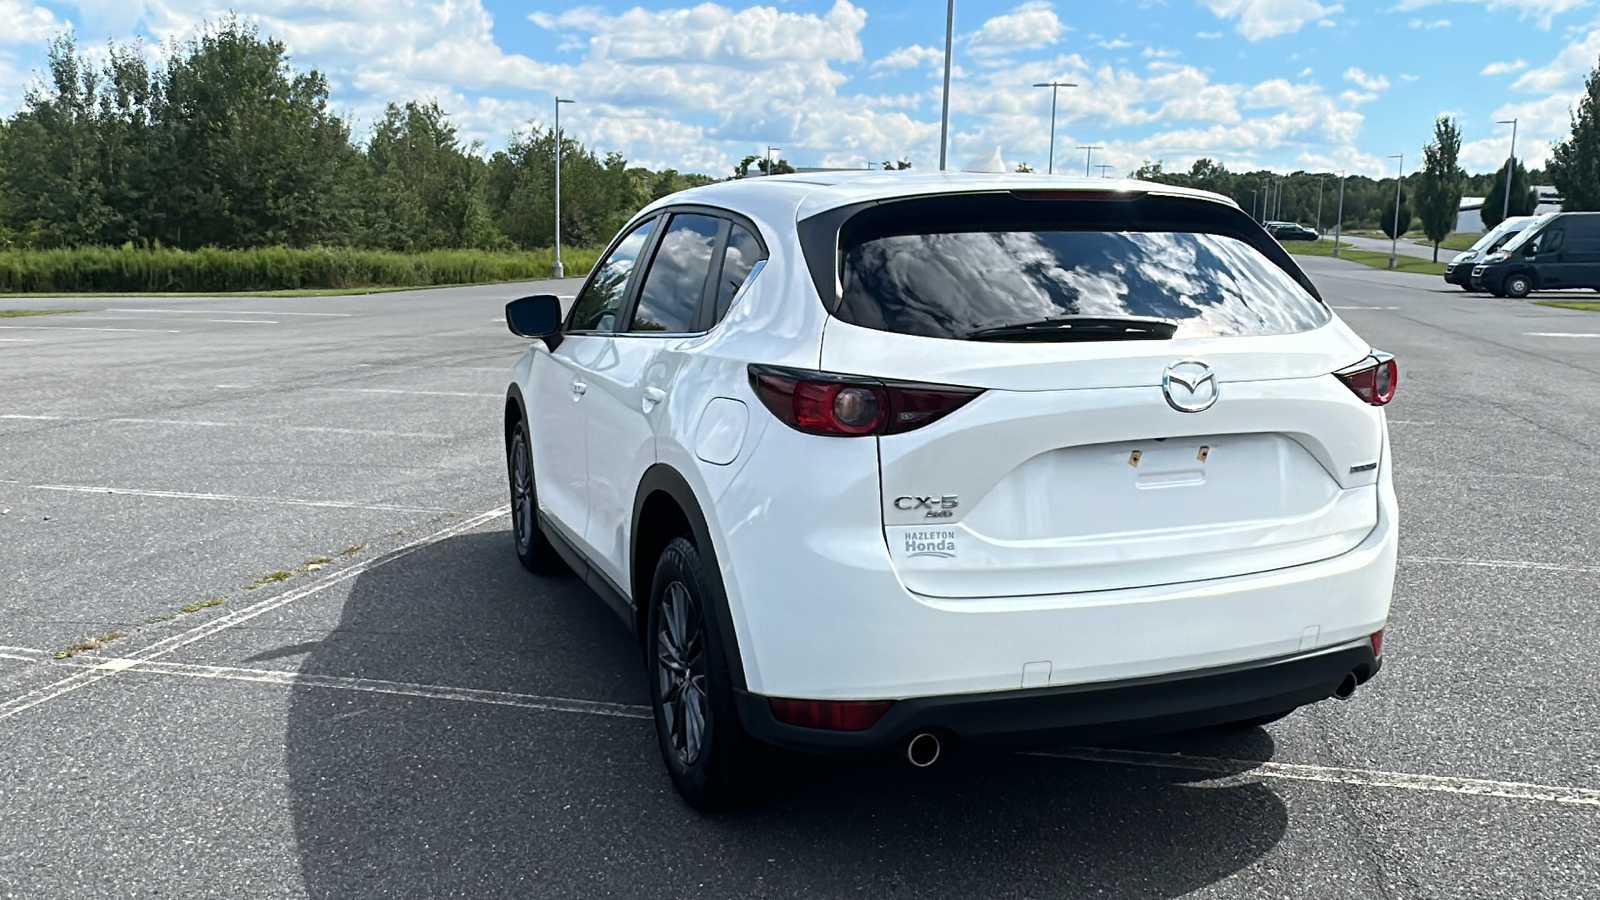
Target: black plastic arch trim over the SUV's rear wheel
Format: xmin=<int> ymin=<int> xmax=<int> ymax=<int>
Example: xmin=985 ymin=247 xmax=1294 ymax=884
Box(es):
xmin=629 ymin=463 xmax=746 ymax=690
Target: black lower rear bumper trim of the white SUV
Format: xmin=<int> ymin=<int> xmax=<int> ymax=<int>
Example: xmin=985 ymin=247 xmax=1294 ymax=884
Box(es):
xmin=739 ymin=639 xmax=1382 ymax=753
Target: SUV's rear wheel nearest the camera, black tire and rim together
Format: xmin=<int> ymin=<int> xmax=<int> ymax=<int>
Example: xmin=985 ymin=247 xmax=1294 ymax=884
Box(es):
xmin=645 ymin=538 xmax=774 ymax=812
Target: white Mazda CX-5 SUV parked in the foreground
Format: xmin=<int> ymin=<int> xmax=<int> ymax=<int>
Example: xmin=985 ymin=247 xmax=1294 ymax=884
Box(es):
xmin=506 ymin=173 xmax=1397 ymax=809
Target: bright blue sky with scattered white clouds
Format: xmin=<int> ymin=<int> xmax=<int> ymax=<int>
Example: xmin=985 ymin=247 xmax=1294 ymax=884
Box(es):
xmin=0 ymin=0 xmax=1600 ymax=175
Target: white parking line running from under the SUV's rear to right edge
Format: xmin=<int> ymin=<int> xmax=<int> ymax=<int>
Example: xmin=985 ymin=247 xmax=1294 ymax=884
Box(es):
xmin=1030 ymin=748 xmax=1600 ymax=806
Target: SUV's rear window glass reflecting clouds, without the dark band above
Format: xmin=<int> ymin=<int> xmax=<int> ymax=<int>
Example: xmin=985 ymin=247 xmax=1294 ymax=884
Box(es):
xmin=837 ymin=229 xmax=1331 ymax=340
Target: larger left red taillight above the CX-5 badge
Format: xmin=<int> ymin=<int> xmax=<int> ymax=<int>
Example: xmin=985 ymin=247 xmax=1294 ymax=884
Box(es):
xmin=750 ymin=365 xmax=982 ymax=437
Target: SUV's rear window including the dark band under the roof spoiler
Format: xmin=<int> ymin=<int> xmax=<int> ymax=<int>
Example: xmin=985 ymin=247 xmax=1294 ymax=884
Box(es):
xmin=835 ymin=192 xmax=1333 ymax=340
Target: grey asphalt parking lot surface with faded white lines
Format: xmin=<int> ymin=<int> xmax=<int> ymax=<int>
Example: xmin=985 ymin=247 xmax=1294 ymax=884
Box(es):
xmin=0 ymin=258 xmax=1600 ymax=898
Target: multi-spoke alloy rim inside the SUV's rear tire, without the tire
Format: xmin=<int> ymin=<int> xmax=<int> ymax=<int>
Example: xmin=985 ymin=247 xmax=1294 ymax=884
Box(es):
xmin=656 ymin=581 xmax=710 ymax=765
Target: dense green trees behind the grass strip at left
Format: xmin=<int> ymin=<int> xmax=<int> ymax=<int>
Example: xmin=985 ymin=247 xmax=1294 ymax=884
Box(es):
xmin=0 ymin=19 xmax=714 ymax=251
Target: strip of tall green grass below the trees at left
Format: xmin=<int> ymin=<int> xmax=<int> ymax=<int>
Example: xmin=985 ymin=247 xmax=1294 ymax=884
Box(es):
xmin=0 ymin=247 xmax=600 ymax=296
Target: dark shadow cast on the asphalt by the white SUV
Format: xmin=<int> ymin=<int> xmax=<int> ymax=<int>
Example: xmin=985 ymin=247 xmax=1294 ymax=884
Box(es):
xmin=284 ymin=532 xmax=1288 ymax=900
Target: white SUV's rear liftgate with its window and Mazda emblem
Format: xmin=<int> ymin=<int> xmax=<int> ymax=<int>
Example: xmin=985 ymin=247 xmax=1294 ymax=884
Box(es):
xmin=822 ymin=200 xmax=1384 ymax=599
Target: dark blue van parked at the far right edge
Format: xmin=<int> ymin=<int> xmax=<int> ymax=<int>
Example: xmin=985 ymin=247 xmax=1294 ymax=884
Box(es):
xmin=1472 ymin=213 xmax=1600 ymax=296
